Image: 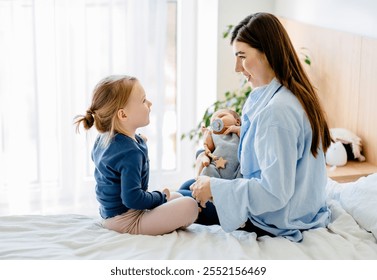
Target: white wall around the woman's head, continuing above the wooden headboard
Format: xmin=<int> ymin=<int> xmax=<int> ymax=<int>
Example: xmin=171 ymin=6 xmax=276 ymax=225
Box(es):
xmin=212 ymin=0 xmax=377 ymax=103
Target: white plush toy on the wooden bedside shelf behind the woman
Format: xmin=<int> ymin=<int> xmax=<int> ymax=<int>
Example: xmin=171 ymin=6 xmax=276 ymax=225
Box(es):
xmin=326 ymin=128 xmax=365 ymax=166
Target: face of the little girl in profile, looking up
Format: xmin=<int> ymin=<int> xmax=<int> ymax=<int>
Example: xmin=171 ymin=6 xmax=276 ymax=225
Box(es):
xmin=119 ymin=82 xmax=152 ymax=132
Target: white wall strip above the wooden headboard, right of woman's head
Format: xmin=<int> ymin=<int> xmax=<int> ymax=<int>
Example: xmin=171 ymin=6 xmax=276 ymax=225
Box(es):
xmin=275 ymin=0 xmax=377 ymax=38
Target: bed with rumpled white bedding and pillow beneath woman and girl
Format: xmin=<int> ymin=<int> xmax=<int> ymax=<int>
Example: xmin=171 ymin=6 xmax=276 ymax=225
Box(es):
xmin=0 ymin=173 xmax=377 ymax=260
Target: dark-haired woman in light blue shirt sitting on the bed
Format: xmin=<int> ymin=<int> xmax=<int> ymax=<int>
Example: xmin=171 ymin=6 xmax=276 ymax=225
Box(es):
xmin=186 ymin=13 xmax=331 ymax=241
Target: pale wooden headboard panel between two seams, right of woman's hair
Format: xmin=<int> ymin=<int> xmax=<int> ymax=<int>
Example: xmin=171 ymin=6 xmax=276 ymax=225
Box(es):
xmin=312 ymin=32 xmax=361 ymax=134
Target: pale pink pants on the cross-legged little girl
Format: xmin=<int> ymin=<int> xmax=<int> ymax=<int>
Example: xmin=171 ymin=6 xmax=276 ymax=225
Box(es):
xmin=102 ymin=193 xmax=198 ymax=235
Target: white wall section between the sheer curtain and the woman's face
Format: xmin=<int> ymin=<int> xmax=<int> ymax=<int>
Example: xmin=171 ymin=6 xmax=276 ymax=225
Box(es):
xmin=195 ymin=0 xmax=275 ymax=115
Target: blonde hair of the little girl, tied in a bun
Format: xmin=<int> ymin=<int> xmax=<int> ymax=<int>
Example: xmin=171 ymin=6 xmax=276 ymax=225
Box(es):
xmin=74 ymin=75 xmax=137 ymax=143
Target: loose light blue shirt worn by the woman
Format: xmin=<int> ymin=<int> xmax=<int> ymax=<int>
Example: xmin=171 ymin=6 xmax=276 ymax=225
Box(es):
xmin=210 ymin=79 xmax=330 ymax=241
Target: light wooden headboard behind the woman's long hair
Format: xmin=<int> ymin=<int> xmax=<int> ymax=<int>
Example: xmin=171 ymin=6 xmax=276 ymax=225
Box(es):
xmin=280 ymin=18 xmax=377 ymax=166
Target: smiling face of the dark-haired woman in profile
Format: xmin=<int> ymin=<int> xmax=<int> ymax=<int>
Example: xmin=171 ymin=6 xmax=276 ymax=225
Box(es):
xmin=233 ymin=41 xmax=275 ymax=88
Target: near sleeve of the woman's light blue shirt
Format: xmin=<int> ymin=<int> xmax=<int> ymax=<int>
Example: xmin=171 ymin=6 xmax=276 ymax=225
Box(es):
xmin=210 ymin=116 xmax=298 ymax=232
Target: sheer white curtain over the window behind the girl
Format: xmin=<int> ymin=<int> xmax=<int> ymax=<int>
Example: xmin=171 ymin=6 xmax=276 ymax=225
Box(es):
xmin=0 ymin=0 xmax=194 ymax=214
